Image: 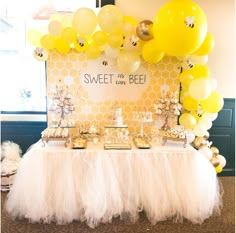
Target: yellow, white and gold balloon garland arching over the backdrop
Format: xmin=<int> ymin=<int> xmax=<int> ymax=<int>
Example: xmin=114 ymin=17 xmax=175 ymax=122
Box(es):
xmin=27 ymin=0 xmax=225 ymax=172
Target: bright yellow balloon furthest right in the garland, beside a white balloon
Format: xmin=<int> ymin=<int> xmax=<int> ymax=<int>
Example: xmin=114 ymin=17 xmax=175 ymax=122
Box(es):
xmin=200 ymin=91 xmax=224 ymax=113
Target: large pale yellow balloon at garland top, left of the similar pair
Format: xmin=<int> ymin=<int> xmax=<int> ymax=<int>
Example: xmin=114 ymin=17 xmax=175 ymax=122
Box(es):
xmin=72 ymin=7 xmax=97 ymax=36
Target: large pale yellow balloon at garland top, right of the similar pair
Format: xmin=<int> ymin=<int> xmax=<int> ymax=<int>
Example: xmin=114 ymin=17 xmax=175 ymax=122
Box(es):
xmin=97 ymin=5 xmax=123 ymax=33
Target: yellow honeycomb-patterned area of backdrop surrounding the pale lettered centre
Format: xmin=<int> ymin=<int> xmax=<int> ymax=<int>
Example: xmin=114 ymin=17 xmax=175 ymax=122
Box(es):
xmin=46 ymin=51 xmax=180 ymax=133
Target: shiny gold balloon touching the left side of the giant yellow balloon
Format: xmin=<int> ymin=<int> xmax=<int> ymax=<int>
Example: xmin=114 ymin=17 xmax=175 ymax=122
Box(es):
xmin=136 ymin=20 xmax=153 ymax=41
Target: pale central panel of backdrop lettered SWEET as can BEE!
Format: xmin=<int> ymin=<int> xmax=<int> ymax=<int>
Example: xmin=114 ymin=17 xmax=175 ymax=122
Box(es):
xmin=79 ymin=56 xmax=150 ymax=101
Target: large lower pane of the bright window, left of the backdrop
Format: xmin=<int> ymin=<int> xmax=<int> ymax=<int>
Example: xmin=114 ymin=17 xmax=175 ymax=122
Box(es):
xmin=0 ymin=16 xmax=46 ymax=112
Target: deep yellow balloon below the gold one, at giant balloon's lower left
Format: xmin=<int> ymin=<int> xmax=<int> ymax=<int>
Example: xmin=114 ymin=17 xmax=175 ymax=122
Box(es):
xmin=142 ymin=39 xmax=165 ymax=63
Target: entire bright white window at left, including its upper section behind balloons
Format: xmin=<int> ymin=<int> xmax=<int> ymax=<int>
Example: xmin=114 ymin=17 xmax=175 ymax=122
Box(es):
xmin=0 ymin=0 xmax=114 ymax=113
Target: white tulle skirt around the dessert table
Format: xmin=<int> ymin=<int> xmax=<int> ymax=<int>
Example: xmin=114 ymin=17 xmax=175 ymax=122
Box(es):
xmin=6 ymin=143 xmax=222 ymax=227
